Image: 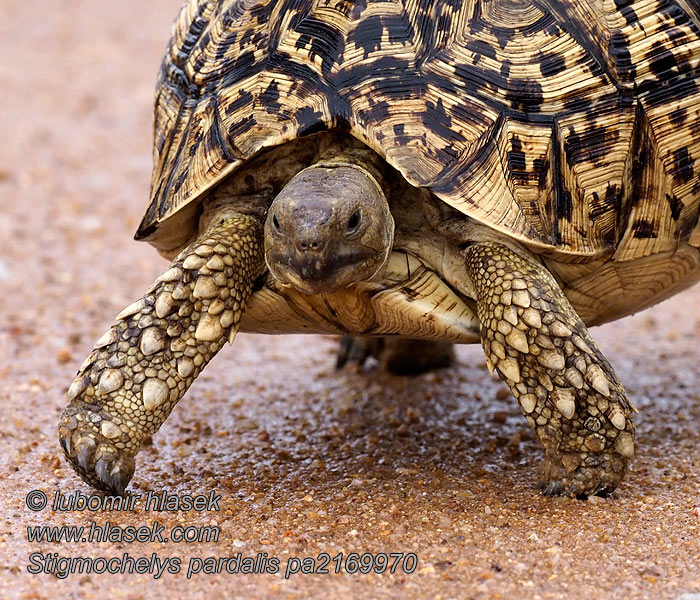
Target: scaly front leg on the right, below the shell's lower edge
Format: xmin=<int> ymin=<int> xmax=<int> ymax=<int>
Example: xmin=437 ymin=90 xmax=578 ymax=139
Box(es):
xmin=465 ymin=243 xmax=634 ymax=497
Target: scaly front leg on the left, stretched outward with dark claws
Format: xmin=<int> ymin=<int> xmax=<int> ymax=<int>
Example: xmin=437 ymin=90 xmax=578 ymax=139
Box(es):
xmin=58 ymin=213 xmax=264 ymax=493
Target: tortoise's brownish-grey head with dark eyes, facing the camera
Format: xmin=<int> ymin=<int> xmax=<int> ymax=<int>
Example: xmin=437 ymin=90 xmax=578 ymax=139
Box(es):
xmin=265 ymin=164 xmax=394 ymax=294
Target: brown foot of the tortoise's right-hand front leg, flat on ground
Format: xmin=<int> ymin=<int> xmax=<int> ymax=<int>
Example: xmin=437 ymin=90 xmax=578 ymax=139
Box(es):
xmin=539 ymin=452 xmax=629 ymax=499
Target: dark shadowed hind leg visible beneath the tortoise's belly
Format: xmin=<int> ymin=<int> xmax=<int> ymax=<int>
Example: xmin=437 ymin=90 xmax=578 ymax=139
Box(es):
xmin=336 ymin=335 xmax=455 ymax=375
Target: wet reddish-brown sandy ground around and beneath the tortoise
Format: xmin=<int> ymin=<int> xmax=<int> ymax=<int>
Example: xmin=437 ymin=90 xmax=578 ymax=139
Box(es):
xmin=0 ymin=0 xmax=700 ymax=600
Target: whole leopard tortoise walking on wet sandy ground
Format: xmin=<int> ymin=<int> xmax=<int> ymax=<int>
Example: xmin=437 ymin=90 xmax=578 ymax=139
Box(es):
xmin=59 ymin=0 xmax=700 ymax=497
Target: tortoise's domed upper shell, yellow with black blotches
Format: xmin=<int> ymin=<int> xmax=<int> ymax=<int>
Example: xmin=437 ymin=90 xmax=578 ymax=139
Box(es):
xmin=137 ymin=0 xmax=700 ymax=262
